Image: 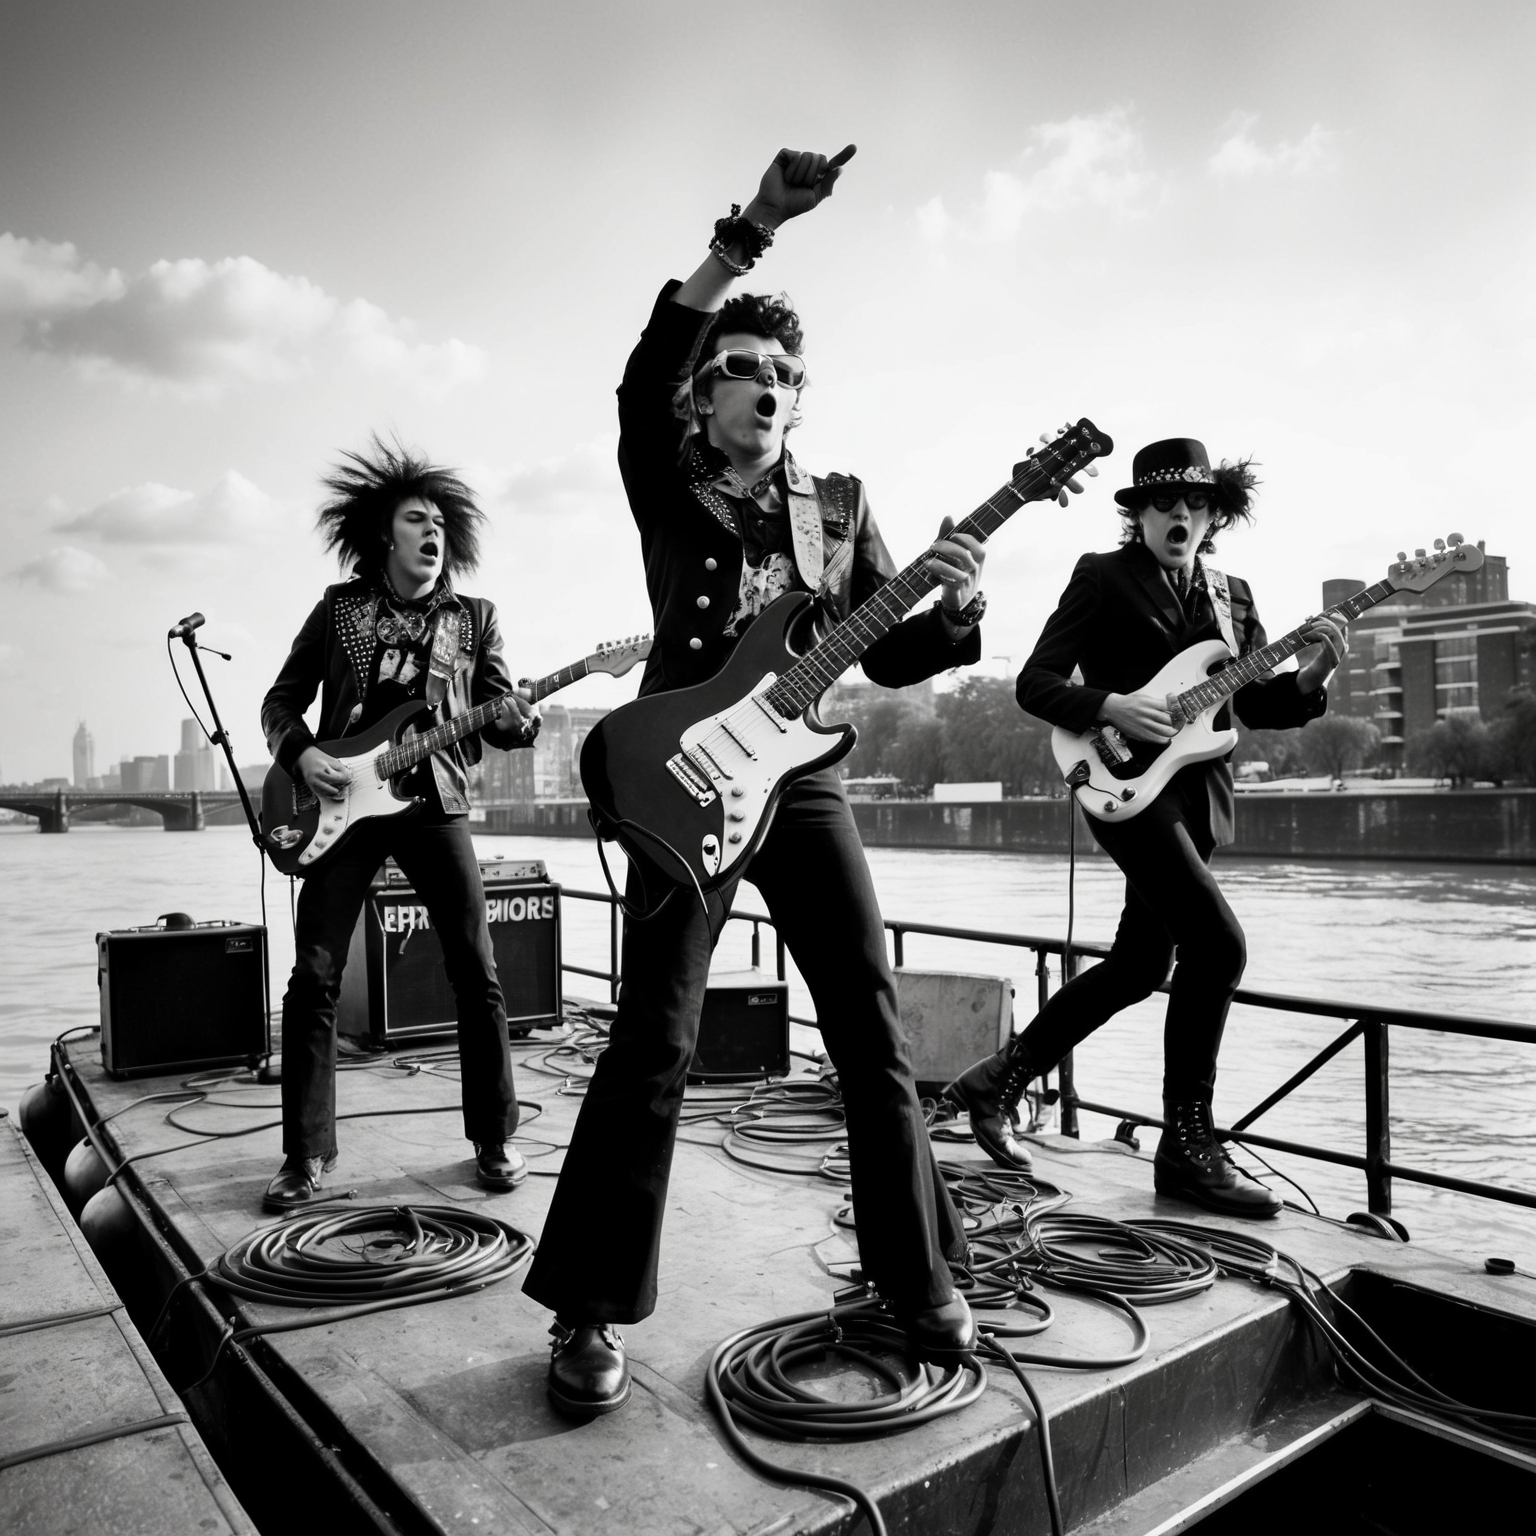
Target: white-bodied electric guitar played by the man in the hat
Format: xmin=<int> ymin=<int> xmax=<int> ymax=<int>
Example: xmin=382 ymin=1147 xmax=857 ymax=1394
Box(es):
xmin=1051 ymin=533 xmax=1482 ymax=822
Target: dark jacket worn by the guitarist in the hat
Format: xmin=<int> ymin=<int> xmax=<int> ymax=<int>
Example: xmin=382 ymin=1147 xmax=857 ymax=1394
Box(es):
xmin=1018 ymin=544 xmax=1327 ymax=846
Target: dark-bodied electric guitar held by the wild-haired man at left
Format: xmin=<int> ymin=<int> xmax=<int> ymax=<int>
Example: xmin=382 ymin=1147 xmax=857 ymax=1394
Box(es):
xmin=261 ymin=634 xmax=651 ymax=876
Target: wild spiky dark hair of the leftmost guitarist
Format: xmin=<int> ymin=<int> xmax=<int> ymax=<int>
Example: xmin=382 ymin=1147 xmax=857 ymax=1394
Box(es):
xmin=316 ymin=433 xmax=485 ymax=576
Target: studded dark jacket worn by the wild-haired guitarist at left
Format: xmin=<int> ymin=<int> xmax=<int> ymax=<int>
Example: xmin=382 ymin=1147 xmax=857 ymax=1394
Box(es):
xmin=261 ymin=579 xmax=531 ymax=816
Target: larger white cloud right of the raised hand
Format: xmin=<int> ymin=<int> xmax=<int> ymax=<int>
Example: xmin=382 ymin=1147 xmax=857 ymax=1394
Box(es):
xmin=917 ymin=106 xmax=1158 ymax=244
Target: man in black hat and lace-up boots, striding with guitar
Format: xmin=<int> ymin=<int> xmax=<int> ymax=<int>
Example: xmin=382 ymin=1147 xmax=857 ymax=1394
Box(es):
xmin=945 ymin=438 xmax=1346 ymax=1217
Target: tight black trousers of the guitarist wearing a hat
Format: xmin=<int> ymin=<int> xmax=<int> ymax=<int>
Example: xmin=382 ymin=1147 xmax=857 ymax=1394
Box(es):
xmin=1021 ymin=770 xmax=1247 ymax=1103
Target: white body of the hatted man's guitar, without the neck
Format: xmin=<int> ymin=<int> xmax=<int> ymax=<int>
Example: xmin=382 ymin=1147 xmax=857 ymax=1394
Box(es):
xmin=1051 ymin=641 xmax=1238 ymax=822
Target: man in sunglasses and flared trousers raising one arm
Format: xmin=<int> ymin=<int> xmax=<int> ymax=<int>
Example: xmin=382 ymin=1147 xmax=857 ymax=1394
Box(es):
xmin=524 ymin=146 xmax=1087 ymax=1418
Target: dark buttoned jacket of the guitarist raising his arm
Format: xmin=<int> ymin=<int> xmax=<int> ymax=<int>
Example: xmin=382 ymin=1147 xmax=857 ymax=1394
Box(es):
xmin=619 ymin=281 xmax=982 ymax=694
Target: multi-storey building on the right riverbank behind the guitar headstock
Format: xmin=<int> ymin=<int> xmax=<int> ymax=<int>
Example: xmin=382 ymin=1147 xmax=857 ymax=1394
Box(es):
xmin=1322 ymin=544 xmax=1536 ymax=766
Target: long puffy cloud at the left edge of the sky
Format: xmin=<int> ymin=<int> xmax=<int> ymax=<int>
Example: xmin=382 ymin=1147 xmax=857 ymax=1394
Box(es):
xmin=0 ymin=235 xmax=485 ymax=396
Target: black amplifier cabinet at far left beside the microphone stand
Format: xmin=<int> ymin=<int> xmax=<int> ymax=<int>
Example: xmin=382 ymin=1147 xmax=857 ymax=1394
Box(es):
xmin=97 ymin=914 xmax=272 ymax=1078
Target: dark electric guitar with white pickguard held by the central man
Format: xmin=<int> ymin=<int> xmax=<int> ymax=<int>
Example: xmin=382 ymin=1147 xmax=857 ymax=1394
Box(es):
xmin=581 ymin=416 xmax=1114 ymax=895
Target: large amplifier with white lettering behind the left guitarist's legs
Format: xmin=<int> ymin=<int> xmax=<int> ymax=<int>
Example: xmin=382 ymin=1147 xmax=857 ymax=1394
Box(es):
xmin=336 ymin=859 xmax=561 ymax=1046
